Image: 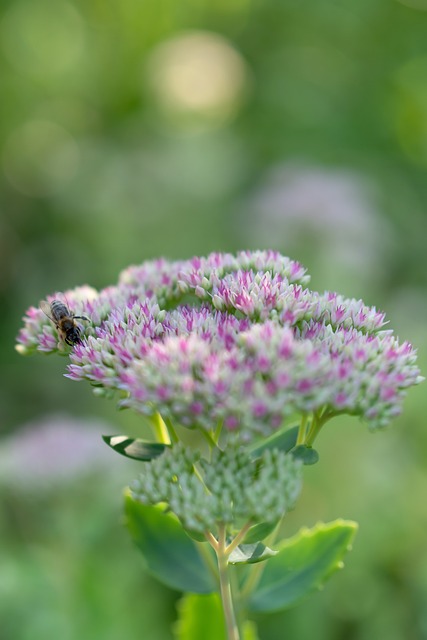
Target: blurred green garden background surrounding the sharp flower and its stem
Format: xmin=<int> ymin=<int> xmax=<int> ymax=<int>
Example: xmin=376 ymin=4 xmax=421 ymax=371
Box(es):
xmin=0 ymin=0 xmax=427 ymax=640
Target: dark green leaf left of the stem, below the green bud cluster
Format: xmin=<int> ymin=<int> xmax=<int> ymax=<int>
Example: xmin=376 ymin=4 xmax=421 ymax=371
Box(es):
xmin=125 ymin=493 xmax=216 ymax=593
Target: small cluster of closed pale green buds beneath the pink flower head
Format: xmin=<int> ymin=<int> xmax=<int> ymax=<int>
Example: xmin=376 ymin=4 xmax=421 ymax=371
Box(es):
xmin=131 ymin=444 xmax=301 ymax=533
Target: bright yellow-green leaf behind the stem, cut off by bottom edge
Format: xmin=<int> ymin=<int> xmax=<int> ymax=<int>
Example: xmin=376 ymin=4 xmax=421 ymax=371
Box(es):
xmin=173 ymin=593 xmax=258 ymax=640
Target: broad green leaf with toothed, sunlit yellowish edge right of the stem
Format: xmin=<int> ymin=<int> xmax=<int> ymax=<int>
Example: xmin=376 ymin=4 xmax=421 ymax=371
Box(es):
xmin=249 ymin=519 xmax=357 ymax=612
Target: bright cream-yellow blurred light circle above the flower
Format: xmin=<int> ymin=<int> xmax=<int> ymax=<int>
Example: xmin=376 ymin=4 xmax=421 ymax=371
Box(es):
xmin=147 ymin=31 xmax=248 ymax=127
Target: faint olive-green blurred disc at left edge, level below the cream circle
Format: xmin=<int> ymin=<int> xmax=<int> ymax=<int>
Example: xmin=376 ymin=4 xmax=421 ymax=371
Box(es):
xmin=2 ymin=120 xmax=80 ymax=196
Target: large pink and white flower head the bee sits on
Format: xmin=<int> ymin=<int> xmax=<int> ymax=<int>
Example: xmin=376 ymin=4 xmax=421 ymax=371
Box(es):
xmin=18 ymin=251 xmax=422 ymax=439
